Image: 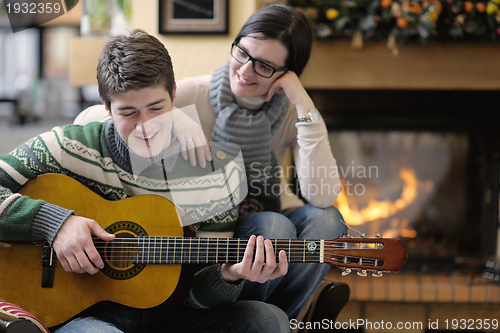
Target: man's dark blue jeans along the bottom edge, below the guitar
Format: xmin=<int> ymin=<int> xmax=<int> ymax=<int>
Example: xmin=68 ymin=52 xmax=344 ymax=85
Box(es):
xmin=51 ymin=301 xmax=290 ymax=333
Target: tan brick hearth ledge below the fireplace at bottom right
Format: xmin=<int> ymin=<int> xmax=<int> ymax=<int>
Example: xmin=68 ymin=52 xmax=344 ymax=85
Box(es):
xmin=327 ymin=269 xmax=500 ymax=333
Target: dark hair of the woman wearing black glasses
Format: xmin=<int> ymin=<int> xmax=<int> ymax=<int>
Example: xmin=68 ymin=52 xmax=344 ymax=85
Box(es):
xmin=234 ymin=5 xmax=313 ymax=76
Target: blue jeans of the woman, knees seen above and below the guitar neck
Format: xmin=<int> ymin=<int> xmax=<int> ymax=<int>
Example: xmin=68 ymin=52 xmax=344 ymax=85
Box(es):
xmin=234 ymin=205 xmax=347 ymax=318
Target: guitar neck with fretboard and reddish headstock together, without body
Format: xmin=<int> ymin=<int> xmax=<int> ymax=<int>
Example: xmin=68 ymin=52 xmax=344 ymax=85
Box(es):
xmin=95 ymin=236 xmax=408 ymax=271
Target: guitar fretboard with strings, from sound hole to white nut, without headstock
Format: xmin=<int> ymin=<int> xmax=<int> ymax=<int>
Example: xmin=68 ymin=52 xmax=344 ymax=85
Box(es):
xmin=101 ymin=236 xmax=325 ymax=264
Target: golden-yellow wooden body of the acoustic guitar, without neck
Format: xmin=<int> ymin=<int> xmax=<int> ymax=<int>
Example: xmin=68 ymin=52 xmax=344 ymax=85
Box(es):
xmin=0 ymin=174 xmax=188 ymax=326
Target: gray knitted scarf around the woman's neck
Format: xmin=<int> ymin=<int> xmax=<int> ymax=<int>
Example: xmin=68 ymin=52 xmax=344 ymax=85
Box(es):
xmin=210 ymin=63 xmax=290 ymax=214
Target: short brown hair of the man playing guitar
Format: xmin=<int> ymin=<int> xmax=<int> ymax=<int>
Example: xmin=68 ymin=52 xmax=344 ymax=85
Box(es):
xmin=97 ymin=29 xmax=175 ymax=110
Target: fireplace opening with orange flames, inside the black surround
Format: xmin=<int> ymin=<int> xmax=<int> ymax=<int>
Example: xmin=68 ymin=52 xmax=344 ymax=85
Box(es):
xmin=329 ymin=131 xmax=481 ymax=270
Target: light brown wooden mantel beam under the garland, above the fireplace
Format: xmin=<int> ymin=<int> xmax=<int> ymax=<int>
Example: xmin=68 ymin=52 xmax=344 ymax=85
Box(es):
xmin=301 ymin=40 xmax=500 ymax=90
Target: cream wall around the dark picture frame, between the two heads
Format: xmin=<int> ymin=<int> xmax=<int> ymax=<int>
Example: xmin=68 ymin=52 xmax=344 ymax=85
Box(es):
xmin=132 ymin=0 xmax=260 ymax=80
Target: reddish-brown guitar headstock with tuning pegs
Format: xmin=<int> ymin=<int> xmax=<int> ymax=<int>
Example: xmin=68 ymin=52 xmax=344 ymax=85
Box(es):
xmin=324 ymin=235 xmax=408 ymax=277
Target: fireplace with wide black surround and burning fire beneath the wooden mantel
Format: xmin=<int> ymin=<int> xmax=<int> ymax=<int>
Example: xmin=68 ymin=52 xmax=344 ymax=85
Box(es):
xmin=309 ymin=90 xmax=500 ymax=272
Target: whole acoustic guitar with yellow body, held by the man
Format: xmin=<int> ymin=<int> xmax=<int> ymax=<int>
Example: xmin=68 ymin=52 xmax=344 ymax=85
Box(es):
xmin=0 ymin=174 xmax=408 ymax=327
